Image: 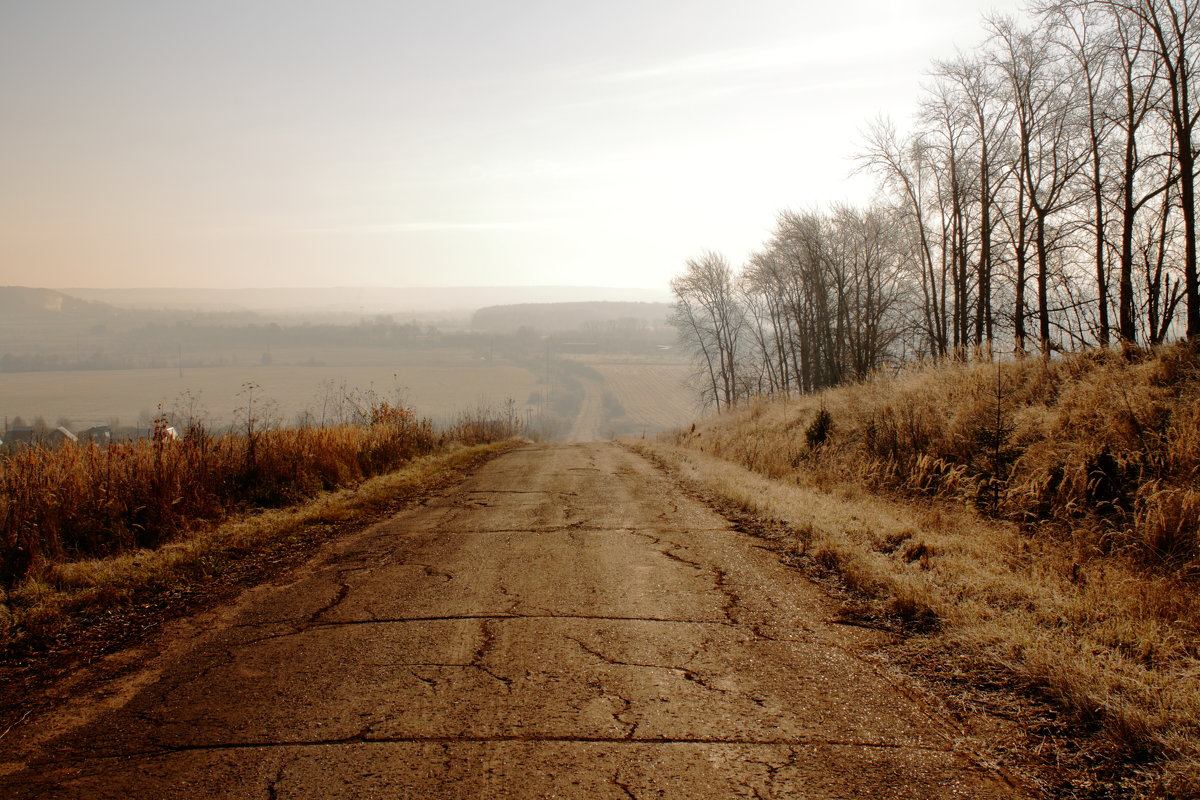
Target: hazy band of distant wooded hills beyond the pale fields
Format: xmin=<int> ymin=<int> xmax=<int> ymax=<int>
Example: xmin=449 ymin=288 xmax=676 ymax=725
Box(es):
xmin=0 ymin=287 xmax=677 ymax=372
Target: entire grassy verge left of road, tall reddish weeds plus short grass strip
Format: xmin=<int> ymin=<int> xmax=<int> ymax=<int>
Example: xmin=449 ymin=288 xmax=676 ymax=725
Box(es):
xmin=0 ymin=403 xmax=517 ymax=652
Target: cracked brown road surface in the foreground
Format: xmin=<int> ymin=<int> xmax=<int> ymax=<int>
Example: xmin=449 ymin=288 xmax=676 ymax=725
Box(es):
xmin=0 ymin=444 xmax=1019 ymax=800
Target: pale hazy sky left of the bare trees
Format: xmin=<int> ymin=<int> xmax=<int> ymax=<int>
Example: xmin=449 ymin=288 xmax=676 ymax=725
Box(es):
xmin=0 ymin=0 xmax=1021 ymax=288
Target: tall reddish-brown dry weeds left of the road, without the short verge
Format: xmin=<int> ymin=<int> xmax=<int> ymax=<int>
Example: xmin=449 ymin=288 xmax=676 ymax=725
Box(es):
xmin=0 ymin=402 xmax=517 ymax=588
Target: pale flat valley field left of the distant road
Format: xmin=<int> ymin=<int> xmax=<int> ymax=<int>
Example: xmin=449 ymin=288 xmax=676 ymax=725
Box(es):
xmin=0 ymin=357 xmax=535 ymax=428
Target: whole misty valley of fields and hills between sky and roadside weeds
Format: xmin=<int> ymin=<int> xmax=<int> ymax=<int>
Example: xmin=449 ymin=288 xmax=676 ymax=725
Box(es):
xmin=0 ymin=287 xmax=695 ymax=439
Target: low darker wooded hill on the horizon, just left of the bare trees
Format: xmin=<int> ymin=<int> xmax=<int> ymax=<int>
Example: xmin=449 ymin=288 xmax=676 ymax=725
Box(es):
xmin=470 ymin=302 xmax=671 ymax=333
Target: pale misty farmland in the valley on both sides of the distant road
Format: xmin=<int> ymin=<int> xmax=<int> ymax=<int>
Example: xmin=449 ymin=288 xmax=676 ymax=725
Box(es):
xmin=0 ymin=348 xmax=698 ymax=437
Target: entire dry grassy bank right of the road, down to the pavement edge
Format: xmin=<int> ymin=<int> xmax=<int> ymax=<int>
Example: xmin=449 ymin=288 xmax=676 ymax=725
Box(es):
xmin=642 ymin=347 xmax=1200 ymax=798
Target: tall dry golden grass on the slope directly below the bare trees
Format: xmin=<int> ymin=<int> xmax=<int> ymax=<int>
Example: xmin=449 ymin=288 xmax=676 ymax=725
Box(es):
xmin=678 ymin=344 xmax=1200 ymax=577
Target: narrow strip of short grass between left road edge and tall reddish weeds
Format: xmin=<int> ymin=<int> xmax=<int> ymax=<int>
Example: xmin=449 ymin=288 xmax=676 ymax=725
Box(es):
xmin=0 ymin=439 xmax=523 ymax=649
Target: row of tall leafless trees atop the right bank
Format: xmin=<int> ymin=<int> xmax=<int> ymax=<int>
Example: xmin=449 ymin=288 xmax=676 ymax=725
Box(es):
xmin=672 ymin=0 xmax=1200 ymax=407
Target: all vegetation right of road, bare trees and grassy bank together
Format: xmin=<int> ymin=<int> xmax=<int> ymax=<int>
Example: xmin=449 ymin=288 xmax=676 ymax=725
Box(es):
xmin=662 ymin=0 xmax=1200 ymax=798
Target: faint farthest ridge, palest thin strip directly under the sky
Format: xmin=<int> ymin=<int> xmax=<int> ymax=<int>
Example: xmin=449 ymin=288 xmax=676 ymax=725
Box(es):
xmin=62 ymin=287 xmax=670 ymax=314
